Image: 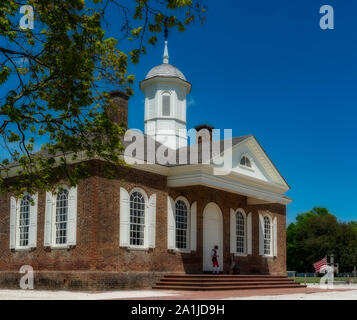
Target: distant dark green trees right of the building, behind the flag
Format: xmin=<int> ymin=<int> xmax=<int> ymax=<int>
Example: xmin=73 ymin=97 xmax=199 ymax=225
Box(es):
xmin=287 ymin=208 xmax=357 ymax=272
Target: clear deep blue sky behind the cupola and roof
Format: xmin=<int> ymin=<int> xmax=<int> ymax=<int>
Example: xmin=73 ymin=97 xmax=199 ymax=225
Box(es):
xmin=0 ymin=0 xmax=357 ymax=222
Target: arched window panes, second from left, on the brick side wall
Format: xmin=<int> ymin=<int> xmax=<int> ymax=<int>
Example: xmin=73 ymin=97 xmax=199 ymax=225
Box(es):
xmin=55 ymin=189 xmax=68 ymax=245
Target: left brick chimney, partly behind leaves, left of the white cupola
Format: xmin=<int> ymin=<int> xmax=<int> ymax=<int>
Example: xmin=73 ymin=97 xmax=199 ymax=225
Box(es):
xmin=106 ymin=90 xmax=129 ymax=127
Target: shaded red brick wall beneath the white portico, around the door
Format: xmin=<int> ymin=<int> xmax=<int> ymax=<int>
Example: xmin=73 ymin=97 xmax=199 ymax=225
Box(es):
xmin=169 ymin=186 xmax=286 ymax=274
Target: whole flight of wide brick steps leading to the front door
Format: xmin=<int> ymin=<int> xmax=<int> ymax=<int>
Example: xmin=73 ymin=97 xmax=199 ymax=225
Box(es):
xmin=153 ymin=274 xmax=306 ymax=290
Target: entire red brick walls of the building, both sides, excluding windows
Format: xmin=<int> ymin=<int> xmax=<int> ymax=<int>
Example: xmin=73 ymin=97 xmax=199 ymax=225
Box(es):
xmin=0 ymin=163 xmax=286 ymax=283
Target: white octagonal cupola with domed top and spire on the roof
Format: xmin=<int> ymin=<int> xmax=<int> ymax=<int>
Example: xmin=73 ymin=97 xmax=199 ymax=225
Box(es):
xmin=140 ymin=40 xmax=191 ymax=149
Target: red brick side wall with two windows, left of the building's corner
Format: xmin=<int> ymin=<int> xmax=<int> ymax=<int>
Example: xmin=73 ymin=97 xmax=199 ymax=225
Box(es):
xmin=0 ymin=177 xmax=97 ymax=271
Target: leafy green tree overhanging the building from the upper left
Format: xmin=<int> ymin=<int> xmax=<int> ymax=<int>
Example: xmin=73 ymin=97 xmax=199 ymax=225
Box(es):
xmin=0 ymin=0 xmax=205 ymax=195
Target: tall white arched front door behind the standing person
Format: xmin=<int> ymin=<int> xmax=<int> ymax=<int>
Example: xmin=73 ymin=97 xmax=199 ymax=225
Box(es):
xmin=203 ymin=202 xmax=223 ymax=271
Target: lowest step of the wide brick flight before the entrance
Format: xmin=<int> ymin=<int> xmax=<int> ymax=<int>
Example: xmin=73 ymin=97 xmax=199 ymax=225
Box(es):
xmin=153 ymin=283 xmax=306 ymax=291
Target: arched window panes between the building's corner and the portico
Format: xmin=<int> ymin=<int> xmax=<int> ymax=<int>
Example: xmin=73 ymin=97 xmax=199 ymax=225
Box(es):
xmin=130 ymin=191 xmax=145 ymax=246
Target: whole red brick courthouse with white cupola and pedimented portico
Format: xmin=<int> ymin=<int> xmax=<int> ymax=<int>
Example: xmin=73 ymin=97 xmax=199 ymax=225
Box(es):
xmin=0 ymin=42 xmax=291 ymax=289
